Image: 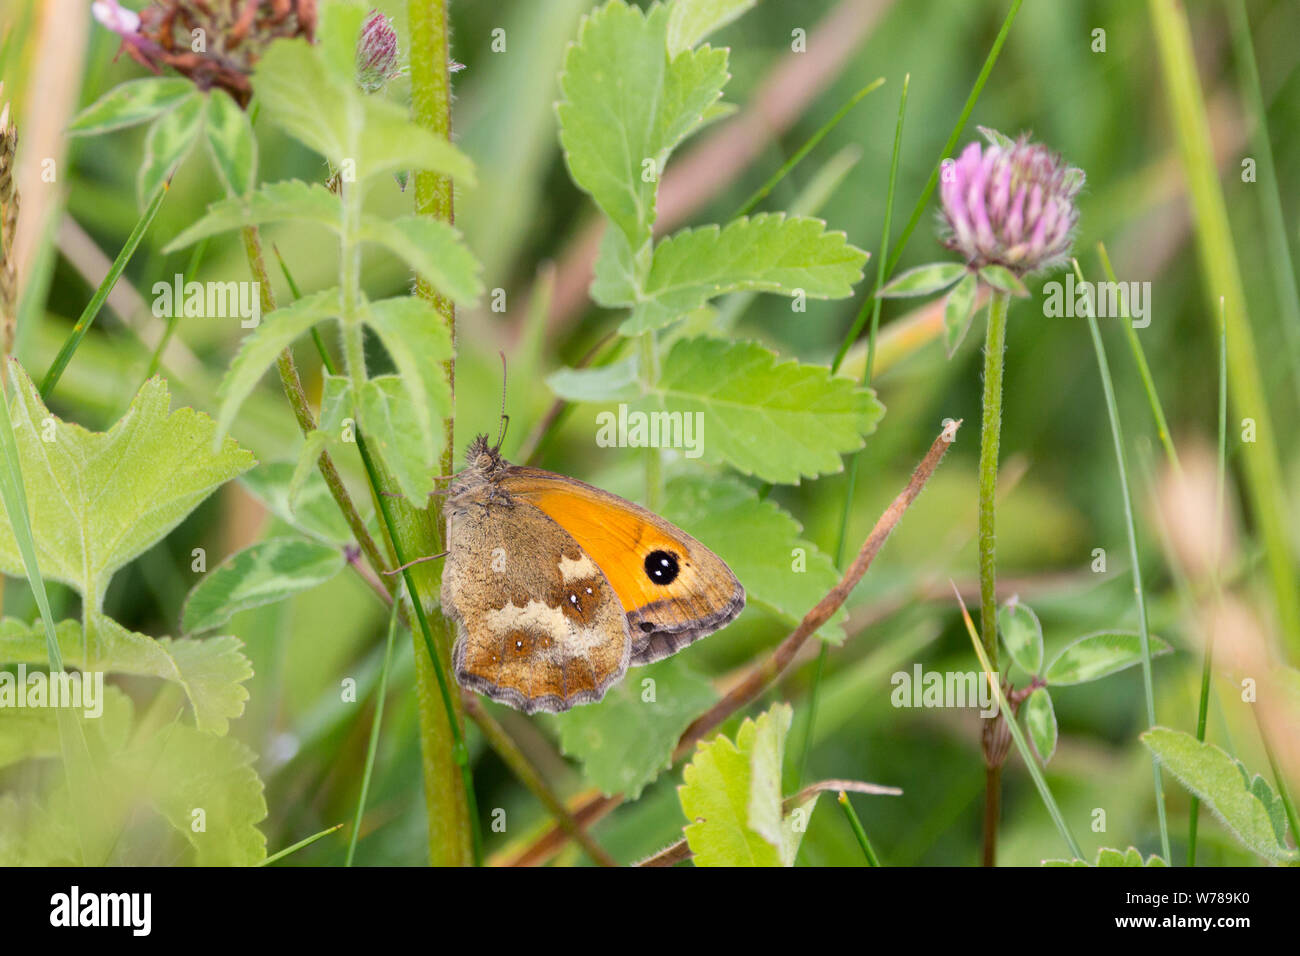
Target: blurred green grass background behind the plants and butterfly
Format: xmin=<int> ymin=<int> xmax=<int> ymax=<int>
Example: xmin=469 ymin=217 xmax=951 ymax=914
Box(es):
xmin=0 ymin=0 xmax=1300 ymax=865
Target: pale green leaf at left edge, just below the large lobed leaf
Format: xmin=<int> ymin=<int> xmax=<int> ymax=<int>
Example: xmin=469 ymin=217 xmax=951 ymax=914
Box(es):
xmin=0 ymin=613 xmax=252 ymax=734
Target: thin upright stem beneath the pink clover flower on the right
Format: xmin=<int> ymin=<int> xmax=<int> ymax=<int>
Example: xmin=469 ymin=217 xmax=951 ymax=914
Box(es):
xmin=979 ymin=291 xmax=1011 ymax=866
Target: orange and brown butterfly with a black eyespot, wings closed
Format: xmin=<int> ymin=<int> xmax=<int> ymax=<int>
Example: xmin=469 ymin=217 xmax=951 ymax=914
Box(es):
xmin=442 ymin=436 xmax=745 ymax=713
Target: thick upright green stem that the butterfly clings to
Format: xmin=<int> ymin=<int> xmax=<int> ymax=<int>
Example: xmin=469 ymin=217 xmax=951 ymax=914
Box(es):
xmin=405 ymin=0 xmax=480 ymax=865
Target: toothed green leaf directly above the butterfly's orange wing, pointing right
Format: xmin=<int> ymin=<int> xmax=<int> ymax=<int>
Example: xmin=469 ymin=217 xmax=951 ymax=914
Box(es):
xmin=646 ymin=338 xmax=884 ymax=483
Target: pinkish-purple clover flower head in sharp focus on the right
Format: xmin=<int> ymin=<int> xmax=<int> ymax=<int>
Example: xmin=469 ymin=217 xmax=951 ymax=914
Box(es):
xmin=940 ymin=131 xmax=1084 ymax=276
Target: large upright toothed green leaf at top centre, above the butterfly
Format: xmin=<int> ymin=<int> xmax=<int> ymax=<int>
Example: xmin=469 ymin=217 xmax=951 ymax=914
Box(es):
xmin=556 ymin=0 xmax=728 ymax=248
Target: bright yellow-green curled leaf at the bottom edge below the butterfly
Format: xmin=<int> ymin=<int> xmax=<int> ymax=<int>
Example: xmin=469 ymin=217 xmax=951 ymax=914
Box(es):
xmin=677 ymin=704 xmax=801 ymax=866
